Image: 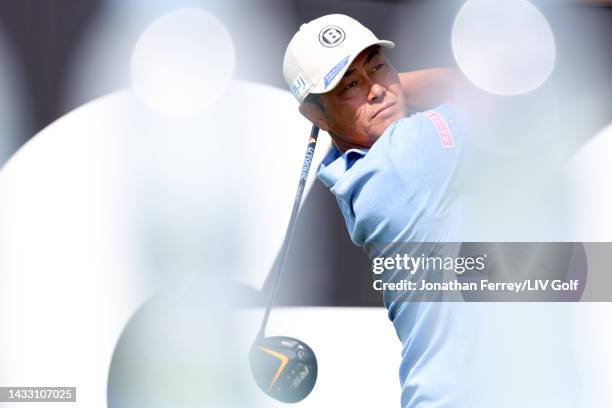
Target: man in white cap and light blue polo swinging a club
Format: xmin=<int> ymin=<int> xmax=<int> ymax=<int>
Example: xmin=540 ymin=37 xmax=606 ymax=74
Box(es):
xmin=283 ymin=14 xmax=469 ymax=408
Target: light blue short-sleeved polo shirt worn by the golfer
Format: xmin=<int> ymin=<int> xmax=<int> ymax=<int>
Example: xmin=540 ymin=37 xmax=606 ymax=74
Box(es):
xmin=317 ymin=105 xmax=466 ymax=408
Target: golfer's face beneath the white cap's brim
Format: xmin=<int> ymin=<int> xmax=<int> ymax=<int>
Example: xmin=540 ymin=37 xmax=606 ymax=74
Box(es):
xmin=306 ymin=46 xmax=407 ymax=151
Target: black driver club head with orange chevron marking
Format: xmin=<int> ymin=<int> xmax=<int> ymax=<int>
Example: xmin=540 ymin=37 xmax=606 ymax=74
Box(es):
xmin=250 ymin=336 xmax=317 ymax=403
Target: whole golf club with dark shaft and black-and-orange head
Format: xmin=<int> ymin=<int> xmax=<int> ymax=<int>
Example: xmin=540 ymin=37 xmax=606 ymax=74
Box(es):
xmin=250 ymin=125 xmax=319 ymax=403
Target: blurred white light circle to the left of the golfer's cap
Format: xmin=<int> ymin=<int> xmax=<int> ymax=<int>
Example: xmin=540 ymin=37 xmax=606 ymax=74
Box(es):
xmin=130 ymin=8 xmax=235 ymax=116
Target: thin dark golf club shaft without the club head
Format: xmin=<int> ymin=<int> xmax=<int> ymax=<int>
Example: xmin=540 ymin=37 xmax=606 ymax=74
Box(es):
xmin=258 ymin=125 xmax=319 ymax=337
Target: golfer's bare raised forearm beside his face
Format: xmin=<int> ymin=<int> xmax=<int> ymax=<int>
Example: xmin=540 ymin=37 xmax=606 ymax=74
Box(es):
xmin=399 ymin=68 xmax=464 ymax=112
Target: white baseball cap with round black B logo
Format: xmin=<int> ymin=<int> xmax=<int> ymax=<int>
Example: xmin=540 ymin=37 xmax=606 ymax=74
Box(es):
xmin=283 ymin=14 xmax=395 ymax=103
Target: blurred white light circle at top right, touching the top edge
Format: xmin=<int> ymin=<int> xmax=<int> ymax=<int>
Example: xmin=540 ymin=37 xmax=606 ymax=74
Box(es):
xmin=452 ymin=0 xmax=556 ymax=96
